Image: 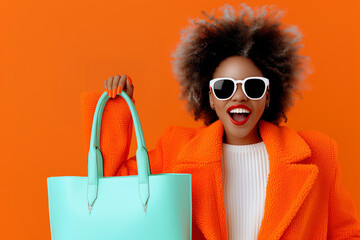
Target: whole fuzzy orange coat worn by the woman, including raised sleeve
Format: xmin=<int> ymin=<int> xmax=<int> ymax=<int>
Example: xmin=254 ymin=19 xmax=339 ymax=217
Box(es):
xmin=81 ymin=92 xmax=360 ymax=240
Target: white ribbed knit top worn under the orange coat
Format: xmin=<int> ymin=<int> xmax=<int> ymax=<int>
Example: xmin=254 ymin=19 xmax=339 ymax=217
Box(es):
xmin=222 ymin=142 xmax=270 ymax=240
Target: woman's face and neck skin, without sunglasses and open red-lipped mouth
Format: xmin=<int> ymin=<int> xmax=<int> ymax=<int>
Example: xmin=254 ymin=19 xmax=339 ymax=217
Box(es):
xmin=209 ymin=56 xmax=270 ymax=145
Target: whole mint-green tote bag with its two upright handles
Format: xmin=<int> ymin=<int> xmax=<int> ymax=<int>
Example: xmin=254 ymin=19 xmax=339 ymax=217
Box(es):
xmin=47 ymin=91 xmax=192 ymax=240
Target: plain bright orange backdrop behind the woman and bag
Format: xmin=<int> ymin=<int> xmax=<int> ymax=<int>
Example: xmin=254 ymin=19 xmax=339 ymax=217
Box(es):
xmin=0 ymin=0 xmax=360 ymax=239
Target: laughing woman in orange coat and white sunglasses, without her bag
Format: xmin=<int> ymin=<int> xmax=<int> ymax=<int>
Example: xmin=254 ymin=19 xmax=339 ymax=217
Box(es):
xmin=82 ymin=4 xmax=360 ymax=240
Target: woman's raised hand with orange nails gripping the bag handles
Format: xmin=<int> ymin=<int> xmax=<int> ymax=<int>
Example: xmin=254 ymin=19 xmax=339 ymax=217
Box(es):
xmin=104 ymin=74 xmax=134 ymax=99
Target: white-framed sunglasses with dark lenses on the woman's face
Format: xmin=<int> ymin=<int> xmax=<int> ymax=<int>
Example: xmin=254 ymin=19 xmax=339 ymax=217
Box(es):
xmin=209 ymin=77 xmax=270 ymax=100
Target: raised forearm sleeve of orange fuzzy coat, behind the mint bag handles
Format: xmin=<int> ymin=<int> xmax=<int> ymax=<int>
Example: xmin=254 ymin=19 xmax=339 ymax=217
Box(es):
xmin=81 ymin=91 xmax=135 ymax=177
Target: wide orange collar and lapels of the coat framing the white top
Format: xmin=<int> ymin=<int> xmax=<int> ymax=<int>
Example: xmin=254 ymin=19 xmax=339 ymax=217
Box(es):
xmin=178 ymin=119 xmax=318 ymax=239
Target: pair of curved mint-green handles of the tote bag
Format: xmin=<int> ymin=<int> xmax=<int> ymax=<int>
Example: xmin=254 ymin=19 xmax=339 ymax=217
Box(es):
xmin=87 ymin=91 xmax=151 ymax=215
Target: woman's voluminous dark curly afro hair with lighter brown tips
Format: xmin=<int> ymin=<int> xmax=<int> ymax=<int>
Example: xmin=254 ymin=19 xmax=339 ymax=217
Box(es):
xmin=171 ymin=3 xmax=311 ymax=126
